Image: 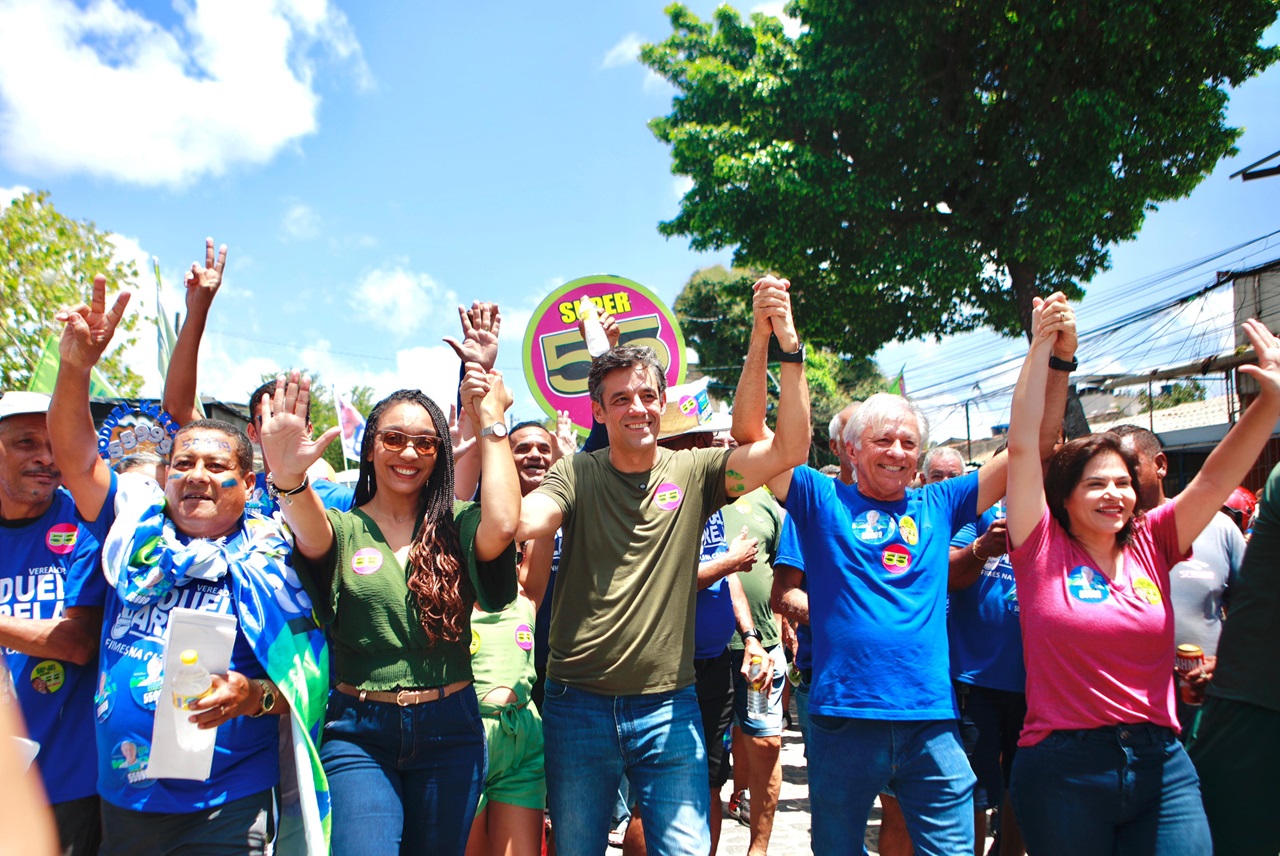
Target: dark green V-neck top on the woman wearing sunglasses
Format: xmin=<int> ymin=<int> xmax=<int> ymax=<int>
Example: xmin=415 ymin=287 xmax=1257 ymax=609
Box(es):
xmin=294 ymin=503 xmax=516 ymax=690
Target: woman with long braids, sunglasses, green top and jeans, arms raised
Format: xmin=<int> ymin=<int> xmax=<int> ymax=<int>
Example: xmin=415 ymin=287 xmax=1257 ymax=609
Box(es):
xmin=261 ymin=363 xmax=520 ymax=856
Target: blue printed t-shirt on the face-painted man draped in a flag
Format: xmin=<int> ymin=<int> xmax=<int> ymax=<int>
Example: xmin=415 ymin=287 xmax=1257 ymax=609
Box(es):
xmin=93 ymin=473 xmax=280 ymax=814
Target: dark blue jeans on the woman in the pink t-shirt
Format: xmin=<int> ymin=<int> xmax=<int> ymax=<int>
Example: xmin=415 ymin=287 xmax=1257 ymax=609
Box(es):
xmin=1011 ymin=724 xmax=1213 ymax=856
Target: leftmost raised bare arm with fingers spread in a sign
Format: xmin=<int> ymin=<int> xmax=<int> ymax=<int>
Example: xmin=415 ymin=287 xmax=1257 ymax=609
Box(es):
xmin=49 ymin=274 xmax=129 ymax=521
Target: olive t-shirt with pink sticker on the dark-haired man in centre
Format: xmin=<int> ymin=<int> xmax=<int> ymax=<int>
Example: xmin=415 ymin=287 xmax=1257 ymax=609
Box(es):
xmin=538 ymin=449 xmax=731 ymax=696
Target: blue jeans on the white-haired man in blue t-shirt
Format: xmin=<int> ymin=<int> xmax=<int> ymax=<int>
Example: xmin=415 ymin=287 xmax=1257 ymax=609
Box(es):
xmin=809 ymin=713 xmax=972 ymax=856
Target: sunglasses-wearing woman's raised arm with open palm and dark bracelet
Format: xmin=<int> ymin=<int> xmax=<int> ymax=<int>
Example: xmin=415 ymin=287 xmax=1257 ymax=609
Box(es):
xmin=257 ymin=371 xmax=342 ymax=559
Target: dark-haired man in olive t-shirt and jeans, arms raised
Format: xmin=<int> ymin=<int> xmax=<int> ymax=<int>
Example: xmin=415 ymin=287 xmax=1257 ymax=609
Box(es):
xmin=517 ymin=278 xmax=809 ymax=856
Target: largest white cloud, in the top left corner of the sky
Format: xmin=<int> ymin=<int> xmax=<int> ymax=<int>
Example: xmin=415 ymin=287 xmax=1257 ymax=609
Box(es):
xmin=0 ymin=0 xmax=370 ymax=186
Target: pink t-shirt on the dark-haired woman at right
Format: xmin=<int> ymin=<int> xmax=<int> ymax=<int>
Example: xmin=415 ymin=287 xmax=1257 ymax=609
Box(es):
xmin=1009 ymin=503 xmax=1187 ymax=746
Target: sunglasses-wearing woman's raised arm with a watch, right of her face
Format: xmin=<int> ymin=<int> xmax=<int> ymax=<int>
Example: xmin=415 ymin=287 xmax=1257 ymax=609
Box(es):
xmin=461 ymin=362 xmax=520 ymax=562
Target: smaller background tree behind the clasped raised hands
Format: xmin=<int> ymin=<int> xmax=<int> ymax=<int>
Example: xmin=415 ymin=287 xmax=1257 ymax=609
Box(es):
xmin=675 ymin=265 xmax=888 ymax=466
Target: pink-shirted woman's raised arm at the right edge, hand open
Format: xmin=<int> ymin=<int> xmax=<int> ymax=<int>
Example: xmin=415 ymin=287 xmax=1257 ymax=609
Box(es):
xmin=1174 ymin=319 xmax=1280 ymax=553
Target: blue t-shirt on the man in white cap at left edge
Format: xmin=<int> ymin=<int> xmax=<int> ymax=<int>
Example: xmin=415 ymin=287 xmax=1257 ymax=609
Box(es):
xmin=0 ymin=487 xmax=106 ymax=804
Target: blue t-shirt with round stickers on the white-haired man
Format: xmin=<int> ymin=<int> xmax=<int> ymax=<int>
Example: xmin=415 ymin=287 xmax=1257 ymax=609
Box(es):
xmin=785 ymin=467 xmax=978 ymax=720
